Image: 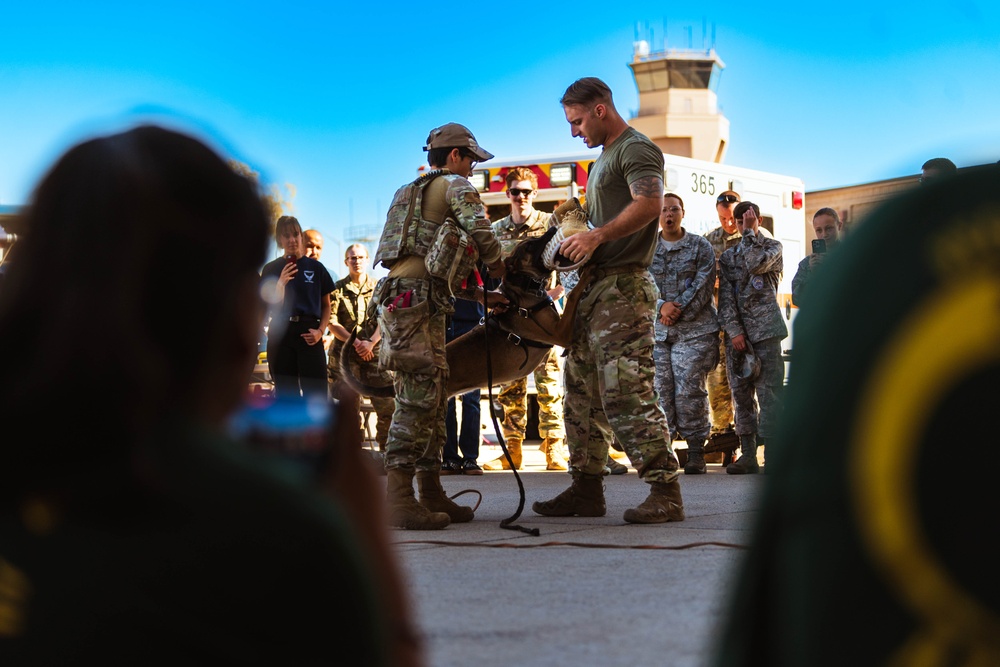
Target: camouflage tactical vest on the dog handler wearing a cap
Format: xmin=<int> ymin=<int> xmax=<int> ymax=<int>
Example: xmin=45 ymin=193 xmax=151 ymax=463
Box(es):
xmin=373 ymin=169 xmax=451 ymax=269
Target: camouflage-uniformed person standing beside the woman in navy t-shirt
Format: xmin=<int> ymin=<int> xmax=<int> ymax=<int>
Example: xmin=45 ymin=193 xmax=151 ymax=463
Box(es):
xmin=327 ymin=243 xmax=395 ymax=460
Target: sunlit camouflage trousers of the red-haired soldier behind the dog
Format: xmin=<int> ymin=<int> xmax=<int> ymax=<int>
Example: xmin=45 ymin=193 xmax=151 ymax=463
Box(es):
xmin=497 ymin=348 xmax=566 ymax=440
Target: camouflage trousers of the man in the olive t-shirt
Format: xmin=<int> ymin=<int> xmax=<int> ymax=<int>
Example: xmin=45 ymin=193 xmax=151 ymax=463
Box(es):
xmin=563 ymin=271 xmax=678 ymax=482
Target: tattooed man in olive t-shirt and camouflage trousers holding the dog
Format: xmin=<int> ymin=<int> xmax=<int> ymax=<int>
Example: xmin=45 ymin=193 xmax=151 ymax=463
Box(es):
xmin=532 ymin=77 xmax=684 ymax=524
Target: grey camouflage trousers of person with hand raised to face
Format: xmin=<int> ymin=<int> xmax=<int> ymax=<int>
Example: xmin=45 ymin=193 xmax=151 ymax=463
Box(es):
xmin=726 ymin=338 xmax=785 ymax=441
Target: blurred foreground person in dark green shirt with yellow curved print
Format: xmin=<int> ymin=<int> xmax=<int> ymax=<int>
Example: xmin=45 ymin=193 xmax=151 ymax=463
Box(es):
xmin=711 ymin=166 xmax=1000 ymax=667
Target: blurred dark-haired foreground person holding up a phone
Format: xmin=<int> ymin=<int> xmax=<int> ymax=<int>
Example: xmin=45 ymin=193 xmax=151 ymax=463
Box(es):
xmin=0 ymin=126 xmax=420 ymax=665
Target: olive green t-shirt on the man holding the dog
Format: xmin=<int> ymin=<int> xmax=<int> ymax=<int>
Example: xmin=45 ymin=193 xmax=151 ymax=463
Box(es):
xmin=586 ymin=127 xmax=663 ymax=267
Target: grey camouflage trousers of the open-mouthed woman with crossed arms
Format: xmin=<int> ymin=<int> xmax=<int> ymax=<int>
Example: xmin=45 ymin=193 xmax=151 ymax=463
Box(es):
xmin=653 ymin=332 xmax=719 ymax=440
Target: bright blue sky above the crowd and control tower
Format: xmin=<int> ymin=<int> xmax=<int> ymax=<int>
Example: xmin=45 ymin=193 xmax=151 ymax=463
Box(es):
xmin=0 ymin=0 xmax=1000 ymax=266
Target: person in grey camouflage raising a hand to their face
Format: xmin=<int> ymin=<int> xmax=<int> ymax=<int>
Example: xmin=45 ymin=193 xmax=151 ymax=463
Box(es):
xmin=719 ymin=202 xmax=788 ymax=475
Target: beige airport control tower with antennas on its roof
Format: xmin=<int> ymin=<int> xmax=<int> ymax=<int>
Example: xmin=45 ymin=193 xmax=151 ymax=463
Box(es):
xmin=628 ymin=40 xmax=729 ymax=162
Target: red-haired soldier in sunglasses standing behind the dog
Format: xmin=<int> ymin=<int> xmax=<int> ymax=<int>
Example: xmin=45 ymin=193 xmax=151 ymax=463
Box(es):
xmin=483 ymin=167 xmax=566 ymax=478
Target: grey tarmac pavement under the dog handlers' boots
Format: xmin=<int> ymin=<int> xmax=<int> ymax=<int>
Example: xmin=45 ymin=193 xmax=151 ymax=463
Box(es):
xmin=382 ymin=440 xmax=766 ymax=667
